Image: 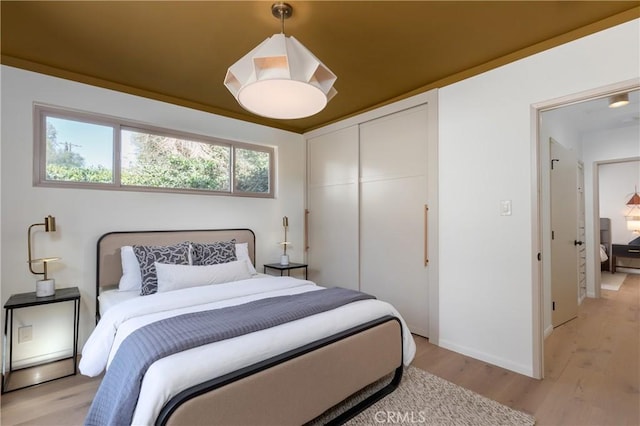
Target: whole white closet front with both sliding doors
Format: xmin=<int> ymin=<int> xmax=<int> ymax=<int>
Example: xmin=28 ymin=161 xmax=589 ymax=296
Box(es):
xmin=307 ymin=105 xmax=429 ymax=336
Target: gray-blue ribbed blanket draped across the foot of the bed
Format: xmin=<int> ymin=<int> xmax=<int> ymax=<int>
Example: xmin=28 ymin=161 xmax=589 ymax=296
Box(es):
xmin=85 ymin=287 xmax=374 ymax=426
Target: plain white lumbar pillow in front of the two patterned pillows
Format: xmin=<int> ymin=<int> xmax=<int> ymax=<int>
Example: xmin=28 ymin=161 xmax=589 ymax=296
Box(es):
xmin=155 ymin=259 xmax=252 ymax=293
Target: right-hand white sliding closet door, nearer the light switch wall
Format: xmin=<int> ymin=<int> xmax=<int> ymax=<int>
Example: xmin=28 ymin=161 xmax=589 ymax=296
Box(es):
xmin=360 ymin=106 xmax=429 ymax=337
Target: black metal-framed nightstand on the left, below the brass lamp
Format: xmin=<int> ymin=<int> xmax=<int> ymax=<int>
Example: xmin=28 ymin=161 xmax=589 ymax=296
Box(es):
xmin=2 ymin=287 xmax=80 ymax=393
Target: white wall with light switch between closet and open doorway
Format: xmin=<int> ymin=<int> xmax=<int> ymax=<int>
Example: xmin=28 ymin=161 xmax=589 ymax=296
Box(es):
xmin=438 ymin=20 xmax=640 ymax=375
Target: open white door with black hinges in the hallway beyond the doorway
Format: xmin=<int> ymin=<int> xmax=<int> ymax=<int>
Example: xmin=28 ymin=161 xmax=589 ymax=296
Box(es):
xmin=549 ymin=139 xmax=579 ymax=327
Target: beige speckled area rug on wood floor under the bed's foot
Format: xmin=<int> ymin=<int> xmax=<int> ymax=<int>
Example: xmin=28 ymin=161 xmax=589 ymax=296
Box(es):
xmin=313 ymin=366 xmax=536 ymax=426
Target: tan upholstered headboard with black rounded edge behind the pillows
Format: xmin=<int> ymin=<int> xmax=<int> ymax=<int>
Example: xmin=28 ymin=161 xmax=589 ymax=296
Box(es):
xmin=96 ymin=229 xmax=256 ymax=313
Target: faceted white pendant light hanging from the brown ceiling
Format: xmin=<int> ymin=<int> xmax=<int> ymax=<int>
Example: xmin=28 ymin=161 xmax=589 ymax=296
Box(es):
xmin=224 ymin=2 xmax=337 ymax=119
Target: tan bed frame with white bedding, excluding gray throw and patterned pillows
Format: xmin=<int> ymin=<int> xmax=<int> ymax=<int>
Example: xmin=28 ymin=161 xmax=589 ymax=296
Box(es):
xmin=80 ymin=229 xmax=415 ymax=425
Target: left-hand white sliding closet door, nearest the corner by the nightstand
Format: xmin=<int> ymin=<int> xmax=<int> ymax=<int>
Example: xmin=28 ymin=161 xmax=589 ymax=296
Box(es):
xmin=307 ymin=126 xmax=358 ymax=290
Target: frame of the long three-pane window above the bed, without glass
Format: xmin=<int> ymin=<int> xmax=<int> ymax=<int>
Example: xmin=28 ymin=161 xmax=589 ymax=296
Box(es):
xmin=33 ymin=104 xmax=276 ymax=198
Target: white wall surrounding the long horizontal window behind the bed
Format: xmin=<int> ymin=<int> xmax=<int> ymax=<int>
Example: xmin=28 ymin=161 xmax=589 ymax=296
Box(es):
xmin=0 ymin=66 xmax=305 ymax=363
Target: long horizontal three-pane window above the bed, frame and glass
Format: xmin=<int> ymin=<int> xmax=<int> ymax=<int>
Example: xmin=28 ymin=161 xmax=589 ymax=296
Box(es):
xmin=34 ymin=105 xmax=274 ymax=198
